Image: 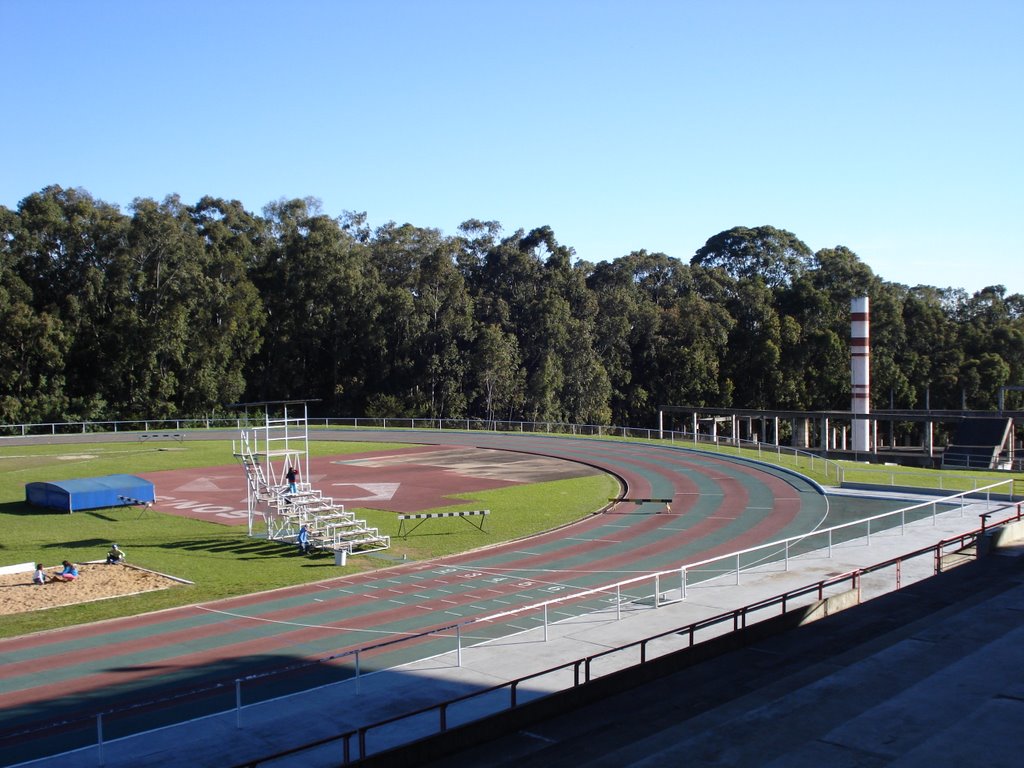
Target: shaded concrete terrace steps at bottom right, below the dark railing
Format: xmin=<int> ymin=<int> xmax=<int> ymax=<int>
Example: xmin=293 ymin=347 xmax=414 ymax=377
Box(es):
xmin=421 ymin=552 xmax=1024 ymax=768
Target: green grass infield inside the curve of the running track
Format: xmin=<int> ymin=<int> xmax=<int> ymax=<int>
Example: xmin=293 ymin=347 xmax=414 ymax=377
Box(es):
xmin=0 ymin=440 xmax=617 ymax=637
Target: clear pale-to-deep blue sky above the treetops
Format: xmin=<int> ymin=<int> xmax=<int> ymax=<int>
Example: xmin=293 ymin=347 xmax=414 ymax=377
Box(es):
xmin=0 ymin=0 xmax=1024 ymax=293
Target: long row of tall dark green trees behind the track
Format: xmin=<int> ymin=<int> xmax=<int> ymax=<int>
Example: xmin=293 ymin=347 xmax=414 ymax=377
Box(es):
xmin=0 ymin=186 xmax=1024 ymax=426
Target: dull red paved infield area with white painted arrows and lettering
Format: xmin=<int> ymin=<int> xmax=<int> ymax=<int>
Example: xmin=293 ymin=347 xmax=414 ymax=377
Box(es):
xmin=140 ymin=445 xmax=597 ymax=525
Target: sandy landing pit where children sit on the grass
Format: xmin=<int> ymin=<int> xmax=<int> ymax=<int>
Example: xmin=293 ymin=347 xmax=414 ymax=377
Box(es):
xmin=0 ymin=563 xmax=181 ymax=615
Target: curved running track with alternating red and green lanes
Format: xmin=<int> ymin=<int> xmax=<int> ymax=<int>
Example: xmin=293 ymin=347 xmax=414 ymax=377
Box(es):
xmin=0 ymin=431 xmax=827 ymax=762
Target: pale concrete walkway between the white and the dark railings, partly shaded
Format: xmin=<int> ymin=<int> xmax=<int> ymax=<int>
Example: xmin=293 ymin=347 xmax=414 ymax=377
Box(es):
xmin=12 ymin=505 xmax=1024 ymax=768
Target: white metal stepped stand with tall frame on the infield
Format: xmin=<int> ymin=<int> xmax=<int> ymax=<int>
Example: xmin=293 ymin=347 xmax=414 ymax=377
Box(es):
xmin=231 ymin=400 xmax=391 ymax=563
